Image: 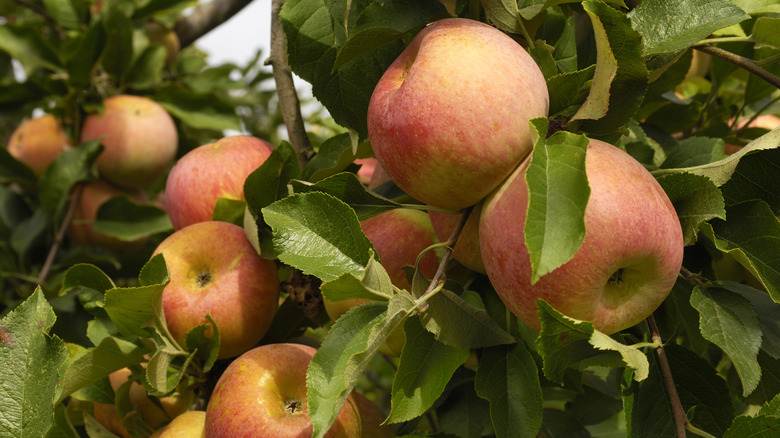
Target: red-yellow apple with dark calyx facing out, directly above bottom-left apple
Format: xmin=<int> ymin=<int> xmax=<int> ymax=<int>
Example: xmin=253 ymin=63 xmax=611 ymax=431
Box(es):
xmin=154 ymin=221 xmax=279 ymax=359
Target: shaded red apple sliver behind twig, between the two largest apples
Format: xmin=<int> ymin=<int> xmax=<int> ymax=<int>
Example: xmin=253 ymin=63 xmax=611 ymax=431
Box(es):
xmin=428 ymin=203 xmax=485 ymax=274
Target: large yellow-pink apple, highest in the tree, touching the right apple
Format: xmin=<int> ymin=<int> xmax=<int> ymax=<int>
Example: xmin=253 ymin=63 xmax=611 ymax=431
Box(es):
xmin=367 ymin=18 xmax=549 ymax=210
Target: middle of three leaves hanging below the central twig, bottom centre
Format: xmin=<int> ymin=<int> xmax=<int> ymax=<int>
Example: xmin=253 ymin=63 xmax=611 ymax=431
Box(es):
xmin=386 ymin=318 xmax=469 ymax=423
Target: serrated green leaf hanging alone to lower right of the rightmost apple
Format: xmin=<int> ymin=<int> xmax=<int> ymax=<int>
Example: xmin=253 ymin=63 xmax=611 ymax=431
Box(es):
xmin=691 ymin=287 xmax=761 ymax=396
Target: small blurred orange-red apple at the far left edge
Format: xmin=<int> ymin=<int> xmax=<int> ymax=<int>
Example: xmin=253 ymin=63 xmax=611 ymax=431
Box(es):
xmin=8 ymin=114 xmax=71 ymax=176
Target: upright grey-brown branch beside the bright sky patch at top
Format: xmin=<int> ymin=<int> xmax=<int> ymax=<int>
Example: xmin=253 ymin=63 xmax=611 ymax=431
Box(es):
xmin=266 ymin=0 xmax=314 ymax=168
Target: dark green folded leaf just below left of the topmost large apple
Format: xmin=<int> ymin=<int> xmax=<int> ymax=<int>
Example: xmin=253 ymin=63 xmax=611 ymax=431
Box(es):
xmin=291 ymin=172 xmax=401 ymax=220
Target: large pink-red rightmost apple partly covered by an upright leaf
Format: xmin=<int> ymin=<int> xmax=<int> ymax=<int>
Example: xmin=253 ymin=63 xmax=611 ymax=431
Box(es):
xmin=479 ymin=140 xmax=684 ymax=334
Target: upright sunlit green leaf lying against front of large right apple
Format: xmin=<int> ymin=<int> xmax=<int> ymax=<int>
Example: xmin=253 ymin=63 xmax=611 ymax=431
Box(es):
xmin=524 ymin=121 xmax=590 ymax=284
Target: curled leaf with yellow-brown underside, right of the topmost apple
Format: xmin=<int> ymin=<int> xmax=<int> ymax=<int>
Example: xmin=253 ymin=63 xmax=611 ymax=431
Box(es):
xmin=572 ymin=1 xmax=649 ymax=135
